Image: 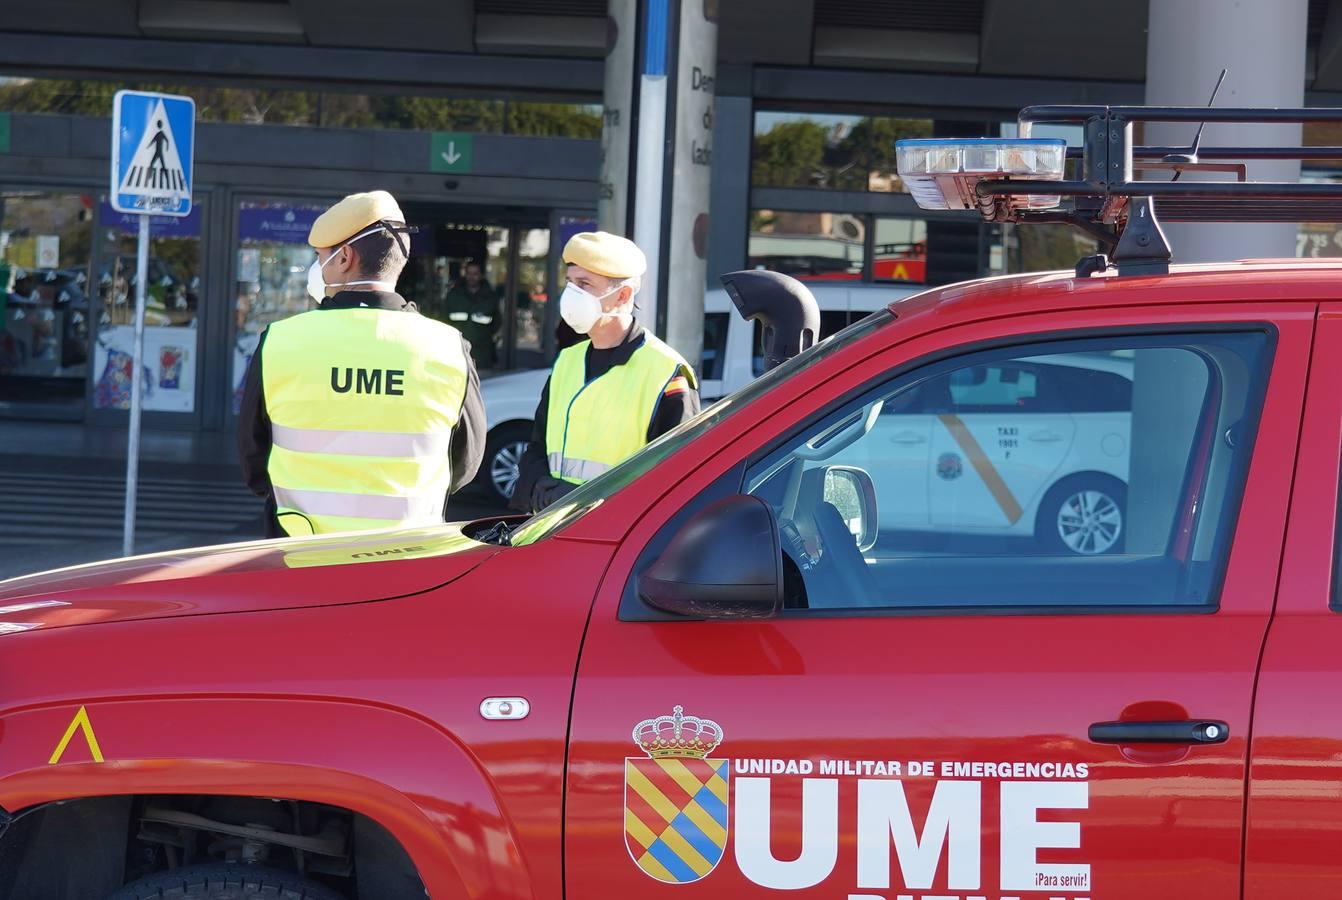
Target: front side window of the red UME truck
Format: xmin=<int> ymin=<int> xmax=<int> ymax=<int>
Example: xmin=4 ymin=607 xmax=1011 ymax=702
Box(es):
xmin=745 ymin=331 xmax=1268 ymax=612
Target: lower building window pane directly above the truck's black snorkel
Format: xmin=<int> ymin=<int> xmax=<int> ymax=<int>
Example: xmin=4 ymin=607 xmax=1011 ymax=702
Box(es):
xmin=749 ymin=209 xmax=867 ymax=282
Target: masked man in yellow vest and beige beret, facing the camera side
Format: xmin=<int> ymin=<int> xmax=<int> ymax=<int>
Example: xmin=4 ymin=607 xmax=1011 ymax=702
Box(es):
xmin=510 ymin=231 xmax=699 ymax=511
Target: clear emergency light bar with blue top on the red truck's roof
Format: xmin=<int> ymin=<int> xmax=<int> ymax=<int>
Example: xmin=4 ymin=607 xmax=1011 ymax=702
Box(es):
xmin=895 ymin=138 xmax=1067 ymax=209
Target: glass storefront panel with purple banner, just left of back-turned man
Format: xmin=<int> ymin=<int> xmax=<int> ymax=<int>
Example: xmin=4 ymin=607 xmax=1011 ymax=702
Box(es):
xmin=228 ymin=201 xmax=325 ymax=414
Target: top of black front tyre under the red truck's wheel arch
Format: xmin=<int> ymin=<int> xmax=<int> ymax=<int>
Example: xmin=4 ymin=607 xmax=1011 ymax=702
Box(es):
xmin=107 ymin=862 xmax=346 ymax=900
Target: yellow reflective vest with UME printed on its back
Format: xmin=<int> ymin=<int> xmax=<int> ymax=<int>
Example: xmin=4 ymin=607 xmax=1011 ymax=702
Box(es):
xmin=262 ymin=307 xmax=467 ymax=535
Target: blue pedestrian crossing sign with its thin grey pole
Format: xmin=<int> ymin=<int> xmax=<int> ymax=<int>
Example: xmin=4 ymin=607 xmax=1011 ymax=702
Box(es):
xmin=107 ymin=91 xmax=196 ymax=557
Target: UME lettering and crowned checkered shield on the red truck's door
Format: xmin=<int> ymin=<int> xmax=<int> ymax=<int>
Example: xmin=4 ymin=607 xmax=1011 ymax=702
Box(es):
xmin=624 ymin=706 xmax=1094 ymax=900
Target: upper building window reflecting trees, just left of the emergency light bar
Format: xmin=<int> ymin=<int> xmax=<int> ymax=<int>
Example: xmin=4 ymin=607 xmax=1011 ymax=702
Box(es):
xmin=750 ymin=111 xmax=933 ymax=192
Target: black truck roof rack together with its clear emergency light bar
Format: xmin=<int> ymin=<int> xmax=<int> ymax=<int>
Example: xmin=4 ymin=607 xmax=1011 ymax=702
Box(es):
xmin=898 ymin=106 xmax=1342 ymax=275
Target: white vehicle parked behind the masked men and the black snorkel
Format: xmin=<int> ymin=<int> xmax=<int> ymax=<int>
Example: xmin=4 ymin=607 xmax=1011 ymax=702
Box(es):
xmin=476 ymin=284 xmax=921 ymax=503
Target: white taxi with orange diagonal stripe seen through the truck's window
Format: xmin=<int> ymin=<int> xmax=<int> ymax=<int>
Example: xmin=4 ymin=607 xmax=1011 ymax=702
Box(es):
xmin=832 ymin=354 xmax=1133 ymax=555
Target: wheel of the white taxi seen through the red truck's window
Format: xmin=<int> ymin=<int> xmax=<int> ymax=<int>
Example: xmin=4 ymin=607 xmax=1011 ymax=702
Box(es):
xmin=1035 ymin=475 xmax=1127 ymax=557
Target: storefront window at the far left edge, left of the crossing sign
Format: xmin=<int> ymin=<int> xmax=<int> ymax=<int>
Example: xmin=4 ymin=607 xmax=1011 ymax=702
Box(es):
xmin=0 ymin=192 xmax=94 ymax=414
